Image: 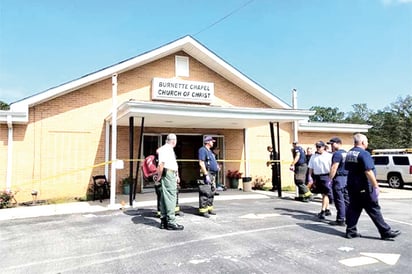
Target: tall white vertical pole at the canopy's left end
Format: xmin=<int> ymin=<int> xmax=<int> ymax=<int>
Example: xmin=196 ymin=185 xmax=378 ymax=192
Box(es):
xmin=109 ymin=73 xmax=117 ymax=208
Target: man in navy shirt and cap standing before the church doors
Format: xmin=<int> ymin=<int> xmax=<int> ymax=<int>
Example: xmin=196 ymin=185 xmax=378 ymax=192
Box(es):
xmin=198 ymin=136 xmax=219 ymax=218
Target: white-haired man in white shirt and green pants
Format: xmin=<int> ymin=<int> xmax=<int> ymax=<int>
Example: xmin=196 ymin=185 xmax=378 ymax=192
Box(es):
xmin=157 ymin=133 xmax=184 ymax=230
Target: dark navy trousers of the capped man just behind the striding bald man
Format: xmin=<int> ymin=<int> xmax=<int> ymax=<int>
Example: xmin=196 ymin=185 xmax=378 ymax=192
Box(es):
xmin=332 ymin=176 xmax=349 ymax=221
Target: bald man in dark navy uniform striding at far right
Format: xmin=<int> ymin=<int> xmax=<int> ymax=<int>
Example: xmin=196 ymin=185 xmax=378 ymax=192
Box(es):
xmin=345 ymin=133 xmax=401 ymax=241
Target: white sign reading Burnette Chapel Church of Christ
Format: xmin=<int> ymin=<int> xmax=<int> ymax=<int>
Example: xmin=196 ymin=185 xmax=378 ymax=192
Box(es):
xmin=152 ymin=78 xmax=214 ymax=104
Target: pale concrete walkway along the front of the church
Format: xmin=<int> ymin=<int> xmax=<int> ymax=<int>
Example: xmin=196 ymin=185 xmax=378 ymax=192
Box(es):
xmin=0 ymin=187 xmax=412 ymax=221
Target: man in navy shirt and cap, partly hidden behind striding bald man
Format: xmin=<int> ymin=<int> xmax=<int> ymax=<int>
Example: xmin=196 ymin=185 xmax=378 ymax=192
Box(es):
xmin=327 ymin=137 xmax=349 ymax=226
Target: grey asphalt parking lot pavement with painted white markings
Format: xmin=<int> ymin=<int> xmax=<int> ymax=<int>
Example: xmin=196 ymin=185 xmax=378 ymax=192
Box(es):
xmin=0 ymin=190 xmax=412 ymax=273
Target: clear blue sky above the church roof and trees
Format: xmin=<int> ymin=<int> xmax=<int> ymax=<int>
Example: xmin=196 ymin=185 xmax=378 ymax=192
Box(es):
xmin=0 ymin=0 xmax=412 ymax=112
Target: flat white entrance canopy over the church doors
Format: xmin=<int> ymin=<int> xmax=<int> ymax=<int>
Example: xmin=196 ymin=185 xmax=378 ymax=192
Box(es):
xmin=106 ymin=101 xmax=314 ymax=129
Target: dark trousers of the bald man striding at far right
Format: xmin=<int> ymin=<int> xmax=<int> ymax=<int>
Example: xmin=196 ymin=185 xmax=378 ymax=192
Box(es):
xmin=346 ymin=190 xmax=391 ymax=235
